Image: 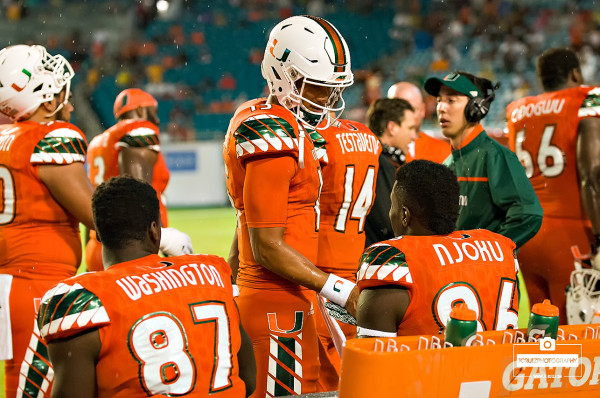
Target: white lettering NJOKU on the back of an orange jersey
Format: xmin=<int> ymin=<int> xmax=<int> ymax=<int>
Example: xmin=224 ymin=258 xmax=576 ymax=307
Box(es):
xmin=433 ymin=240 xmax=504 ymax=265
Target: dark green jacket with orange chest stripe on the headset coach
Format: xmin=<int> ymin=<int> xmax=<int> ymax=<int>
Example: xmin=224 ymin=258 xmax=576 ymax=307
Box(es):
xmin=444 ymin=125 xmax=543 ymax=248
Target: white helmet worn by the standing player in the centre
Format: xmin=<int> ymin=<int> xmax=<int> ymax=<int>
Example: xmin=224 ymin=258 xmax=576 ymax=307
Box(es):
xmin=261 ymin=16 xmax=354 ymax=129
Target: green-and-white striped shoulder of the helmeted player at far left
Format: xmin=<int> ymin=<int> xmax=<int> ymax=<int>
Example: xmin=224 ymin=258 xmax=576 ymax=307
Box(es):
xmin=30 ymin=122 xmax=87 ymax=164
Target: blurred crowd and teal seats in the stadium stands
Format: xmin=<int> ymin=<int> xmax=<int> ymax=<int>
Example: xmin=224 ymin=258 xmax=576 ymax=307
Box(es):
xmin=0 ymin=0 xmax=600 ymax=140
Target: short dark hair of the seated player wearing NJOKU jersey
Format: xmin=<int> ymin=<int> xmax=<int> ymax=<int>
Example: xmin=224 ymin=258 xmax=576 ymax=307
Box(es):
xmin=394 ymin=159 xmax=460 ymax=235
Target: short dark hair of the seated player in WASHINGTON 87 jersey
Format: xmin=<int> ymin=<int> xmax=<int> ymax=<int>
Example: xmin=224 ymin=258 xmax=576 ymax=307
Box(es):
xmin=92 ymin=175 xmax=160 ymax=249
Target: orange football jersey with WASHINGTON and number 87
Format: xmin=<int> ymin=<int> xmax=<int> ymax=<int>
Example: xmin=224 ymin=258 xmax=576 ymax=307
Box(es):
xmin=38 ymin=255 xmax=245 ymax=398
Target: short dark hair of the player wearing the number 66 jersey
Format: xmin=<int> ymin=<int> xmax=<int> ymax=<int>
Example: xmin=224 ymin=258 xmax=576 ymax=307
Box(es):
xmin=536 ymin=48 xmax=580 ymax=91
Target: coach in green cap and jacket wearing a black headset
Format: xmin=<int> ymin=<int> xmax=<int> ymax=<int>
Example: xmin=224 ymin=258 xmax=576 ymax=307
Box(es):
xmin=425 ymin=72 xmax=543 ymax=249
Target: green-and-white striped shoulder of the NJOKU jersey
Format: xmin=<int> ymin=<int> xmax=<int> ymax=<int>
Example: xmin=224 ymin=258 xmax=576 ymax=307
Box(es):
xmin=357 ymin=243 xmax=412 ymax=289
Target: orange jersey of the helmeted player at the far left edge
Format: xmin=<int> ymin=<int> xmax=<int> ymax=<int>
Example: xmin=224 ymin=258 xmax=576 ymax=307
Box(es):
xmin=0 ymin=121 xmax=87 ymax=279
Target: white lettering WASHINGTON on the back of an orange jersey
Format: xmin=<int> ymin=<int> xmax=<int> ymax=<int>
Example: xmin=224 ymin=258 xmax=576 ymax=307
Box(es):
xmin=115 ymin=264 xmax=225 ymax=301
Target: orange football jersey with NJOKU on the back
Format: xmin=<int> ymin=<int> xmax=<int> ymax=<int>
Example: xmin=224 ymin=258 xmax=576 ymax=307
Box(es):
xmin=358 ymin=229 xmax=519 ymax=336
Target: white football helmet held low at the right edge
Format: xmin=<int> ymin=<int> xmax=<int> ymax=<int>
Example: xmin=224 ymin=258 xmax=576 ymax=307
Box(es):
xmin=566 ymin=261 xmax=600 ymax=325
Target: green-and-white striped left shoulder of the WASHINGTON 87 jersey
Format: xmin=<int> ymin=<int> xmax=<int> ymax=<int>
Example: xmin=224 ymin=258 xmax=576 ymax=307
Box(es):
xmin=37 ymin=282 xmax=110 ymax=341
